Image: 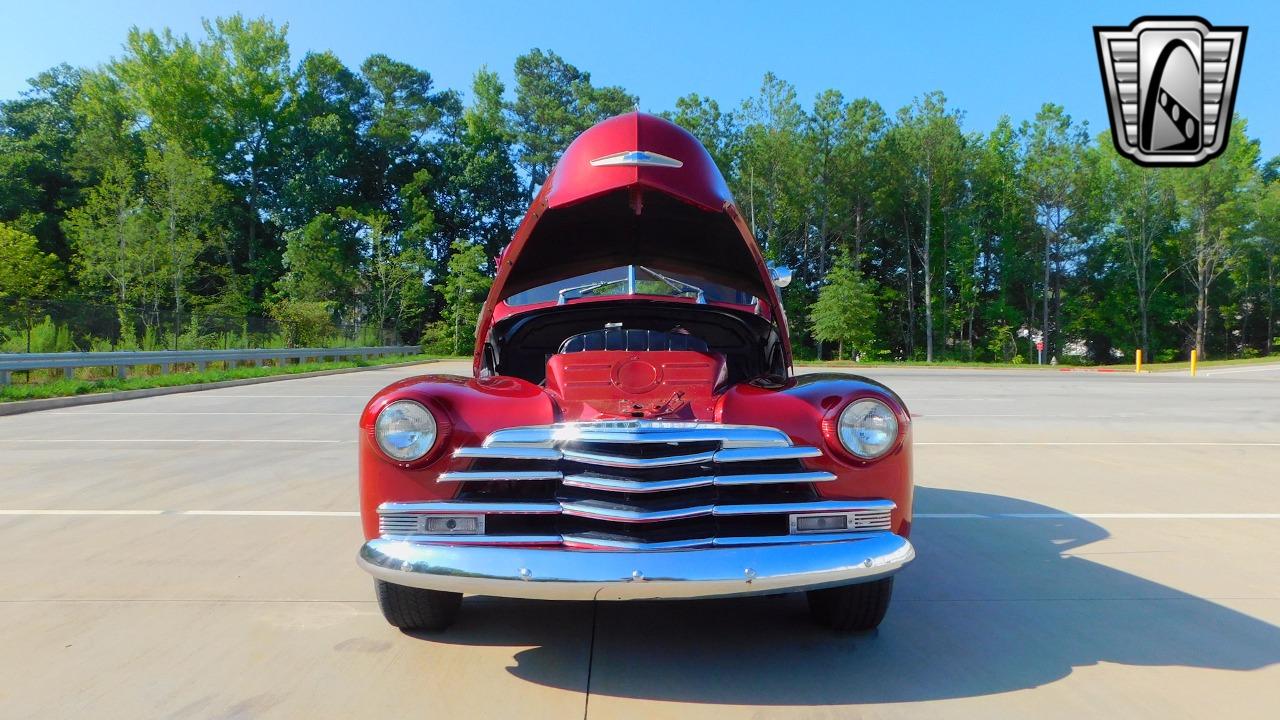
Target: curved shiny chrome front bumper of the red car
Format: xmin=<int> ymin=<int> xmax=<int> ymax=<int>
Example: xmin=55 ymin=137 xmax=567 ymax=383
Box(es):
xmin=358 ymin=532 xmax=915 ymax=600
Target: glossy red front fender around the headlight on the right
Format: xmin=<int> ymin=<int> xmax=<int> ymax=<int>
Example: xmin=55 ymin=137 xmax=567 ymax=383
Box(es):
xmin=716 ymin=373 xmax=913 ymax=537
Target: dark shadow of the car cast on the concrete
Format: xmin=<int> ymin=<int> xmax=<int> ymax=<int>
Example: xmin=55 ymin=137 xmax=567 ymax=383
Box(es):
xmin=401 ymin=487 xmax=1280 ymax=706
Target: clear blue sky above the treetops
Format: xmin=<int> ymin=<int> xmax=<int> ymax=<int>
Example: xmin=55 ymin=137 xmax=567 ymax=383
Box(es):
xmin=0 ymin=0 xmax=1280 ymax=156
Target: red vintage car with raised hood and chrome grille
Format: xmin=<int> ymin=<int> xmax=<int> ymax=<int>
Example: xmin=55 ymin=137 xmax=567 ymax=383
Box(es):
xmin=358 ymin=113 xmax=915 ymax=630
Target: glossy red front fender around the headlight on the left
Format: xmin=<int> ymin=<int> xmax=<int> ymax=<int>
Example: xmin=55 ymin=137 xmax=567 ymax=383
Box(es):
xmin=358 ymin=375 xmax=557 ymax=539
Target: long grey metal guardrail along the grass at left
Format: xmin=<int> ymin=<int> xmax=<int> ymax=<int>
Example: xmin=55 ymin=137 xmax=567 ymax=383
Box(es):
xmin=0 ymin=345 xmax=422 ymax=386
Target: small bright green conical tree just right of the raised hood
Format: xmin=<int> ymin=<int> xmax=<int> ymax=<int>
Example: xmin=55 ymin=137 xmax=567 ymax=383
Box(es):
xmin=810 ymin=251 xmax=879 ymax=360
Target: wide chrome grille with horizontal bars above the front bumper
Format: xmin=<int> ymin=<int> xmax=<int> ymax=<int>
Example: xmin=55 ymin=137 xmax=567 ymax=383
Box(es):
xmin=379 ymin=420 xmax=895 ymax=550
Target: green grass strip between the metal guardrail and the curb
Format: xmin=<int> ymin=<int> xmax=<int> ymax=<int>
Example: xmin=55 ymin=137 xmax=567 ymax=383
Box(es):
xmin=0 ymin=355 xmax=465 ymax=402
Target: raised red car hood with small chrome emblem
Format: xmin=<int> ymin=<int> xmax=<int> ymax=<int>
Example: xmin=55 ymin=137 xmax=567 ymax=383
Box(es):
xmin=480 ymin=113 xmax=785 ymax=311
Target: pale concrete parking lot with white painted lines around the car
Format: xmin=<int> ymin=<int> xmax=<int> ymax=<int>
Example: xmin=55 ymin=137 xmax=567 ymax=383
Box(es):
xmin=0 ymin=363 xmax=1280 ymax=719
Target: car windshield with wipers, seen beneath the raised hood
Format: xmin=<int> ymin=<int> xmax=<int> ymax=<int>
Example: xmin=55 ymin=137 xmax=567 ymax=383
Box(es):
xmin=507 ymin=265 xmax=755 ymax=305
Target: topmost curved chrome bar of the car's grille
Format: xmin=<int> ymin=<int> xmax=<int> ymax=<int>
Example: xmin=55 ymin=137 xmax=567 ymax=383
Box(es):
xmin=484 ymin=420 xmax=791 ymax=447
